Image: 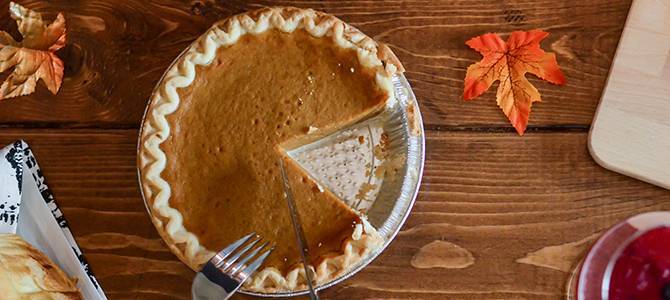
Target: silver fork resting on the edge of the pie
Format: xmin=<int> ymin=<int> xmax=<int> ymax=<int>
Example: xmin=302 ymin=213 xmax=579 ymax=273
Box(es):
xmin=191 ymin=233 xmax=274 ymax=300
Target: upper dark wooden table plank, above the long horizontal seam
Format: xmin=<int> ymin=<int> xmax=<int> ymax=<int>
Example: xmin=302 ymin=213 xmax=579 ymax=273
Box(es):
xmin=0 ymin=0 xmax=630 ymax=128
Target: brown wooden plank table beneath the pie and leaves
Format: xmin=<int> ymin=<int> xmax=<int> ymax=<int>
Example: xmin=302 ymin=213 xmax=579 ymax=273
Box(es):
xmin=0 ymin=0 xmax=670 ymax=299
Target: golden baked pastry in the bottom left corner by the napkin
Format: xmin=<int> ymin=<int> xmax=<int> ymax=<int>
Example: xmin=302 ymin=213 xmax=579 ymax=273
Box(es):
xmin=0 ymin=234 xmax=83 ymax=300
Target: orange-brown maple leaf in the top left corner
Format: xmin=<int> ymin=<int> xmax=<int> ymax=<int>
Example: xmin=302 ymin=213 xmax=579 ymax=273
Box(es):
xmin=0 ymin=2 xmax=65 ymax=100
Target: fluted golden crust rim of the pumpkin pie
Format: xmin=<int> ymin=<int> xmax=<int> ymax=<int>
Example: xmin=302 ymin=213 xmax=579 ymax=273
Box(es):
xmin=138 ymin=7 xmax=404 ymax=293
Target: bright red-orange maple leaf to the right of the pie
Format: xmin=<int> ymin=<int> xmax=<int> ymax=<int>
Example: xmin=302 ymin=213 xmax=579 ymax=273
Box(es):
xmin=463 ymin=30 xmax=565 ymax=135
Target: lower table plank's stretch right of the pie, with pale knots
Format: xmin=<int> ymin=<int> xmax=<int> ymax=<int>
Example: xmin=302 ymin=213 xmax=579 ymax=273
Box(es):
xmin=329 ymin=132 xmax=670 ymax=299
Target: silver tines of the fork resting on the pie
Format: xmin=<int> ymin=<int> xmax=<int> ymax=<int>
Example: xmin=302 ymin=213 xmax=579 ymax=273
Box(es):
xmin=209 ymin=233 xmax=274 ymax=282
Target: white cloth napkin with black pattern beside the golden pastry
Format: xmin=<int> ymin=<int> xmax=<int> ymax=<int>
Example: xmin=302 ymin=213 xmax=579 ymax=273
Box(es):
xmin=0 ymin=141 xmax=107 ymax=299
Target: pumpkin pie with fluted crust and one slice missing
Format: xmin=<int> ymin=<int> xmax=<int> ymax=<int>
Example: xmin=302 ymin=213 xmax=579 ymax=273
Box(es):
xmin=138 ymin=8 xmax=402 ymax=292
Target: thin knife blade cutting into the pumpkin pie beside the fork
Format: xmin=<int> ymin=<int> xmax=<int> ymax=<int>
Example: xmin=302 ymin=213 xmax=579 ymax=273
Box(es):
xmin=279 ymin=158 xmax=319 ymax=300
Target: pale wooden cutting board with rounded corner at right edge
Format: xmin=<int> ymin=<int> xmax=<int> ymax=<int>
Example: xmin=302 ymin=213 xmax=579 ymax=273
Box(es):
xmin=589 ymin=0 xmax=670 ymax=189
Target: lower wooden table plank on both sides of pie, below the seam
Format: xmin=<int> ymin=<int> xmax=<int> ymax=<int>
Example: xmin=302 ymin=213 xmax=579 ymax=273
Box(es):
xmin=0 ymin=129 xmax=670 ymax=299
